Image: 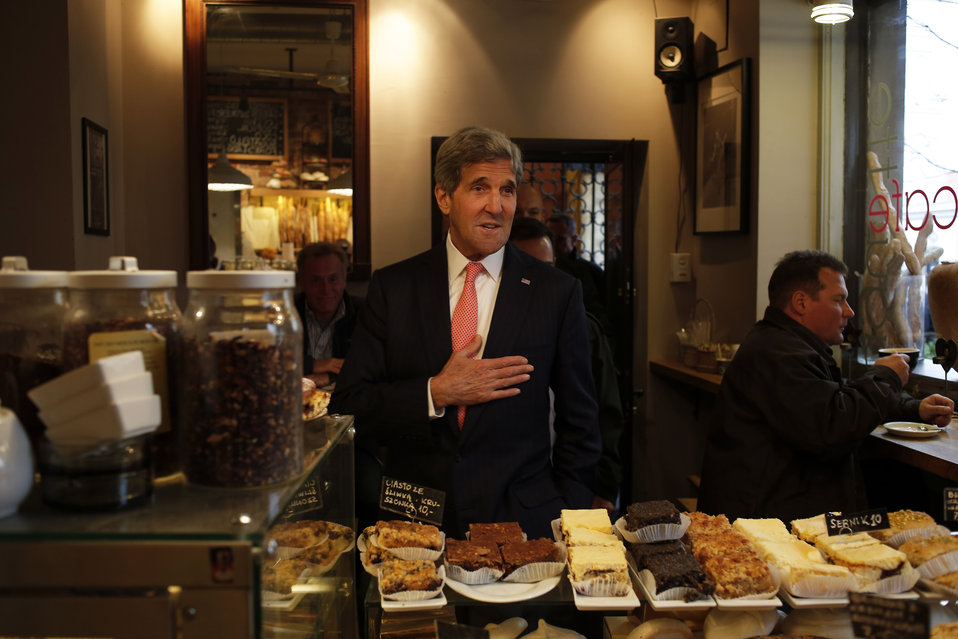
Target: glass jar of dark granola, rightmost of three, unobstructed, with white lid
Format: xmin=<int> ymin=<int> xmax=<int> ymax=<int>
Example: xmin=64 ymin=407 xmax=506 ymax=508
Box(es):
xmin=181 ymin=271 xmax=303 ymax=487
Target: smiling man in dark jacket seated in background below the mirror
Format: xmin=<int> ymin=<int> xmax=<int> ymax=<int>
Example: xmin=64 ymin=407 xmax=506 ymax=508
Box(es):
xmin=295 ymin=242 xmax=362 ymax=387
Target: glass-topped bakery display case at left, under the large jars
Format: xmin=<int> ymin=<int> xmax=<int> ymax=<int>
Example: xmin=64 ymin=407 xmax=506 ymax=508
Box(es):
xmin=0 ymin=416 xmax=358 ymax=639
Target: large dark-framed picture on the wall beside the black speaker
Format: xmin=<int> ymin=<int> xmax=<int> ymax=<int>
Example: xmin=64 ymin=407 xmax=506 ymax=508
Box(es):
xmin=694 ymin=58 xmax=751 ymax=235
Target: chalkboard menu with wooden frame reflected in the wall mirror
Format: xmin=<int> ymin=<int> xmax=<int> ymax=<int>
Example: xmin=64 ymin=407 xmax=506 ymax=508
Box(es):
xmin=206 ymin=97 xmax=286 ymax=160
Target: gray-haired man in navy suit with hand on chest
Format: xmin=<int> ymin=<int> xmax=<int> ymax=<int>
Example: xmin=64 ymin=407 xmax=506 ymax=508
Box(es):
xmin=331 ymin=127 xmax=601 ymax=538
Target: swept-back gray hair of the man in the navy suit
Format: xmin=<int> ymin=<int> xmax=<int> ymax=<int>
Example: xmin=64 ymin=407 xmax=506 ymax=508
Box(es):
xmin=433 ymin=126 xmax=522 ymax=193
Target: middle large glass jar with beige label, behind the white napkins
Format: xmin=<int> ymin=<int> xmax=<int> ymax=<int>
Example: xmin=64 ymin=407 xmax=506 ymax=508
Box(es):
xmin=63 ymin=257 xmax=183 ymax=476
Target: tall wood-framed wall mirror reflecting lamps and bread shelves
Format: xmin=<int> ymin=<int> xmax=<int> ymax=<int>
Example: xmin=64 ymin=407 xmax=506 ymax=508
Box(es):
xmin=184 ymin=0 xmax=371 ymax=279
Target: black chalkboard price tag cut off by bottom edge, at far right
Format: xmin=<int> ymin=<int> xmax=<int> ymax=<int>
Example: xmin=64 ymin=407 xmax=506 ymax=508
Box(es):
xmin=848 ymin=592 xmax=928 ymax=639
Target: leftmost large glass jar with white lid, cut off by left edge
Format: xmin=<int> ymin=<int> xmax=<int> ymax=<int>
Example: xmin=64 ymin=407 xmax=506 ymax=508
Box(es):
xmin=0 ymin=256 xmax=67 ymax=450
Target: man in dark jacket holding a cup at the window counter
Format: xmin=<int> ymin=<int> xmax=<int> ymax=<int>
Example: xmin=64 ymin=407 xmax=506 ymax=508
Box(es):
xmin=698 ymin=251 xmax=954 ymax=521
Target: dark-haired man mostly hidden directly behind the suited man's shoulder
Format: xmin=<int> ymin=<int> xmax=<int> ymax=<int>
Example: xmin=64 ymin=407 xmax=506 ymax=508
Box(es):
xmin=509 ymin=218 xmax=625 ymax=517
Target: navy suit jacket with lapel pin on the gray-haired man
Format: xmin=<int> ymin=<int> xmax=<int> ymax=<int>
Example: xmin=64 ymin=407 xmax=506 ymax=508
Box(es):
xmin=331 ymin=242 xmax=601 ymax=538
